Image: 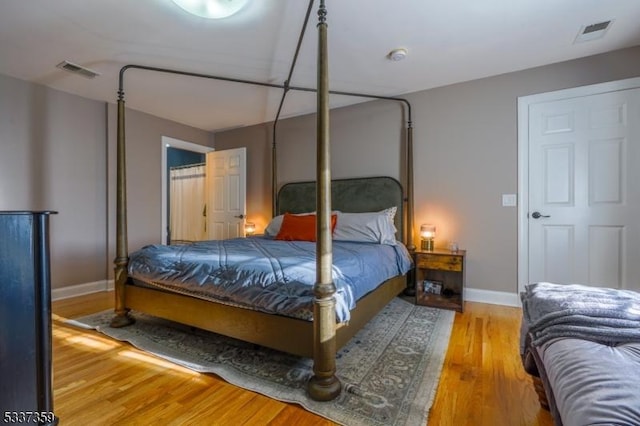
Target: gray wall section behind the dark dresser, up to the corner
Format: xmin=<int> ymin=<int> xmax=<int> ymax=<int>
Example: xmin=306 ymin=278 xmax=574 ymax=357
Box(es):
xmin=0 ymin=76 xmax=107 ymax=287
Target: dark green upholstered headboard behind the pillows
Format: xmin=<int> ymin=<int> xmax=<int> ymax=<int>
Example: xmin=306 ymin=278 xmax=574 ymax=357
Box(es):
xmin=276 ymin=176 xmax=404 ymax=241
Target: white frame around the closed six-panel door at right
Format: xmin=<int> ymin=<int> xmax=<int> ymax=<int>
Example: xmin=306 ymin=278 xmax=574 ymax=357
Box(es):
xmin=518 ymin=77 xmax=640 ymax=300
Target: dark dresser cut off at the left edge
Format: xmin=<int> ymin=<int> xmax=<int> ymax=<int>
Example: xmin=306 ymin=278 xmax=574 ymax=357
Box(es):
xmin=0 ymin=211 xmax=58 ymax=425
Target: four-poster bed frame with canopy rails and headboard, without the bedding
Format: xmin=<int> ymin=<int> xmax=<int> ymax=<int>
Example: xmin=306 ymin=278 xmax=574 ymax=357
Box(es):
xmin=111 ymin=0 xmax=415 ymax=401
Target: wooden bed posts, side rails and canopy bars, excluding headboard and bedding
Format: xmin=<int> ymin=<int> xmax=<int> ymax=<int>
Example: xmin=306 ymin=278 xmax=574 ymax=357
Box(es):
xmin=111 ymin=0 xmax=415 ymax=401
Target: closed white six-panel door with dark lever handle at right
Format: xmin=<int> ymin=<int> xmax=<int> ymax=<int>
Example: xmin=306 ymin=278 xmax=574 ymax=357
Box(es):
xmin=528 ymin=89 xmax=640 ymax=289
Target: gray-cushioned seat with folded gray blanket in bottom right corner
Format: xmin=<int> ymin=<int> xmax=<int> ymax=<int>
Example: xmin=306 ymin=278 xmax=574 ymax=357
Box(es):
xmin=520 ymin=283 xmax=640 ymax=426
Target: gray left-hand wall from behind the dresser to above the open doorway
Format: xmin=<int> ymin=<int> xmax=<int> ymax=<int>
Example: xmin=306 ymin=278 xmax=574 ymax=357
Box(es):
xmin=0 ymin=75 xmax=213 ymax=288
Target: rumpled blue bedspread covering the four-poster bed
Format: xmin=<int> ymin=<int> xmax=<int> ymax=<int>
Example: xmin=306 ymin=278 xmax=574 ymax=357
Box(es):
xmin=129 ymin=237 xmax=411 ymax=322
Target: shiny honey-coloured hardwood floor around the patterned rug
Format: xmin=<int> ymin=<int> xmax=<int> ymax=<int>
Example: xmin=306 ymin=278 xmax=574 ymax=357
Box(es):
xmin=53 ymin=293 xmax=553 ymax=426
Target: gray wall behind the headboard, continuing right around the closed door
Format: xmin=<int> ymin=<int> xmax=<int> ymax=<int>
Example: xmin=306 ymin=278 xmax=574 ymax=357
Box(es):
xmin=216 ymin=47 xmax=640 ymax=300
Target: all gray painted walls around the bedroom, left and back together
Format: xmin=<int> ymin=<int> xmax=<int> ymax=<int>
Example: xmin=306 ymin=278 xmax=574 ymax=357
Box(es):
xmin=0 ymin=47 xmax=640 ymax=293
